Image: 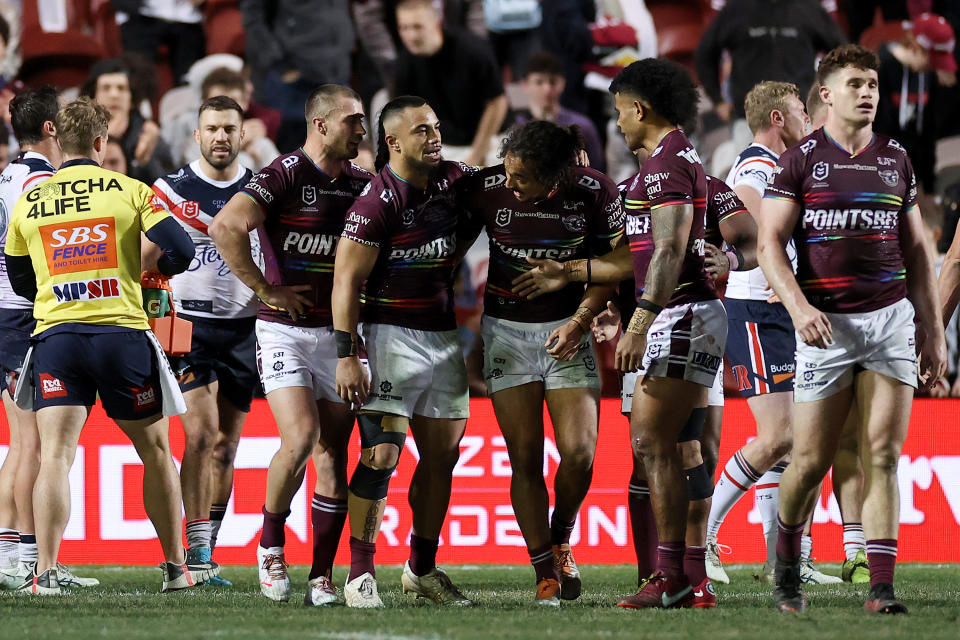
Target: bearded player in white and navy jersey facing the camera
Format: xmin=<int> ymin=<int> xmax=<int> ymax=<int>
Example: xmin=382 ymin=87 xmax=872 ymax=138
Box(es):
xmin=145 ymin=96 xmax=260 ymax=586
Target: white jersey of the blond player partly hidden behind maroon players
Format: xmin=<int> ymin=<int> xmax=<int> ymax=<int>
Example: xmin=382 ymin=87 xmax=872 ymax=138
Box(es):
xmin=724 ymin=142 xmax=797 ymax=300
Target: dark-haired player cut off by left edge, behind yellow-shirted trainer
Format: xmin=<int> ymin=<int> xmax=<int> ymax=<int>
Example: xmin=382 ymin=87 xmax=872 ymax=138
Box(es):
xmin=0 ymin=87 xmax=100 ymax=589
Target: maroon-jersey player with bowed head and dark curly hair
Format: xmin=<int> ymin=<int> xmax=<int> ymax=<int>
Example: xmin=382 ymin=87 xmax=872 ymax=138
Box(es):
xmin=455 ymin=121 xmax=623 ymax=606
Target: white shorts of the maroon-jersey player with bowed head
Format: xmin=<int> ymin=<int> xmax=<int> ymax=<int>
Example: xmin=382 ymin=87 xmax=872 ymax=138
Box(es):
xmin=482 ymin=315 xmax=600 ymax=394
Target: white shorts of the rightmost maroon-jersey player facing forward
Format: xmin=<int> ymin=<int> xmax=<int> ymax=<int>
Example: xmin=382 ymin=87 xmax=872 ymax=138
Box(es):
xmin=793 ymin=298 xmax=918 ymax=402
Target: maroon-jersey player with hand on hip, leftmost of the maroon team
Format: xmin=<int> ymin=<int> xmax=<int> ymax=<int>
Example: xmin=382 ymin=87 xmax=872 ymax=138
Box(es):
xmin=208 ymin=84 xmax=372 ymax=606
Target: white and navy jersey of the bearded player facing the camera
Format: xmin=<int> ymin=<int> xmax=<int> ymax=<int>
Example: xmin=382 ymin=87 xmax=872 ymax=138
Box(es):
xmin=153 ymin=160 xmax=260 ymax=318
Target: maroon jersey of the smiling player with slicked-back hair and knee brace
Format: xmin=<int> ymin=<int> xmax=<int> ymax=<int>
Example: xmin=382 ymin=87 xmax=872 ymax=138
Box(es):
xmin=343 ymin=161 xmax=474 ymax=331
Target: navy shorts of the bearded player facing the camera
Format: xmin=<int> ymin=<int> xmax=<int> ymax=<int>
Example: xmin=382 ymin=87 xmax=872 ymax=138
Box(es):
xmin=170 ymin=313 xmax=260 ymax=411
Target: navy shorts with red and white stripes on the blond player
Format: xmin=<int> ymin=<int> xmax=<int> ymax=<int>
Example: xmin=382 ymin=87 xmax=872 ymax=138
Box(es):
xmin=723 ymin=298 xmax=797 ymax=398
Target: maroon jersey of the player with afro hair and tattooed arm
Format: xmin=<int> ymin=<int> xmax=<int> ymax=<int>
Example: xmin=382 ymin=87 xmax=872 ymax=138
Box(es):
xmin=624 ymin=129 xmax=717 ymax=307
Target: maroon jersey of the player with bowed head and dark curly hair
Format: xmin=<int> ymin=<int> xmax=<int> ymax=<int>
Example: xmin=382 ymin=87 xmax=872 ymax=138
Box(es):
xmin=455 ymin=165 xmax=623 ymax=322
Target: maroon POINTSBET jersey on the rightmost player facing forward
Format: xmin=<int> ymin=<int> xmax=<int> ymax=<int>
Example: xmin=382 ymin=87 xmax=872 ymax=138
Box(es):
xmin=764 ymin=128 xmax=917 ymax=313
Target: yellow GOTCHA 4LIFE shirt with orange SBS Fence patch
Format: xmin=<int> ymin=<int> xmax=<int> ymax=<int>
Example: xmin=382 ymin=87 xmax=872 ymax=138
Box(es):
xmin=5 ymin=160 xmax=170 ymax=335
